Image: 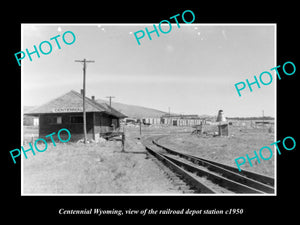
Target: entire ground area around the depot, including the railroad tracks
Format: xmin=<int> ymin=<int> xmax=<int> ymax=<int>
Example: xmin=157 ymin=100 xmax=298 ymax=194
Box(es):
xmin=22 ymin=116 xmax=275 ymax=195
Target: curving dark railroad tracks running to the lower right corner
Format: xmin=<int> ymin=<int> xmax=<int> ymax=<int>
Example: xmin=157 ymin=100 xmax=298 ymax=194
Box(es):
xmin=143 ymin=135 xmax=275 ymax=194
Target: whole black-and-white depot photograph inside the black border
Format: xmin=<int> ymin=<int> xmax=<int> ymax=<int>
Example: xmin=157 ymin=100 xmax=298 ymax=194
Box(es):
xmin=20 ymin=22 xmax=276 ymax=196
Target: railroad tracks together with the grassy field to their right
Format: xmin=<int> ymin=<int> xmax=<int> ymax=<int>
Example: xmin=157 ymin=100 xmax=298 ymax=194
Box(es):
xmin=138 ymin=121 xmax=275 ymax=194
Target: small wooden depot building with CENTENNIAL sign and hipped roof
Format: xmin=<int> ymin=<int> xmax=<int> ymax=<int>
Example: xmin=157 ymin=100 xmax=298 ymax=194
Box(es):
xmin=24 ymin=90 xmax=126 ymax=141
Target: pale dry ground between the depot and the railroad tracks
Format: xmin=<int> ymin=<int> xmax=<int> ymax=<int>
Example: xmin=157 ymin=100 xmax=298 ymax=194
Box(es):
xmin=22 ymin=125 xmax=182 ymax=194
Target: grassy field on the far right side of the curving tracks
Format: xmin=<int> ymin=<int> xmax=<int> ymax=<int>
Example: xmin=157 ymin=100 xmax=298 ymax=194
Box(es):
xmin=159 ymin=126 xmax=277 ymax=177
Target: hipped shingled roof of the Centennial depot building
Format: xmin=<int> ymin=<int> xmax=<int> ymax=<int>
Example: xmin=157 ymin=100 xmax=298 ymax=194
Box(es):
xmin=24 ymin=90 xmax=127 ymax=118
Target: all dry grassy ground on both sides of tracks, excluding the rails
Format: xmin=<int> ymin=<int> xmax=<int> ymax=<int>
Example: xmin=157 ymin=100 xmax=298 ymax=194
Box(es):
xmin=22 ymin=122 xmax=274 ymax=195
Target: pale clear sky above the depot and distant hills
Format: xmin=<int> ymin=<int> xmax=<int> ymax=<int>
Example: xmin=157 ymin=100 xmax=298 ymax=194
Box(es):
xmin=21 ymin=23 xmax=276 ymax=117
